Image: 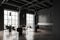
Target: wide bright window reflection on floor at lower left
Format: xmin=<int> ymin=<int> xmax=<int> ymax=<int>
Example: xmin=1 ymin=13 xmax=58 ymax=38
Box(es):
xmin=3 ymin=30 xmax=18 ymax=40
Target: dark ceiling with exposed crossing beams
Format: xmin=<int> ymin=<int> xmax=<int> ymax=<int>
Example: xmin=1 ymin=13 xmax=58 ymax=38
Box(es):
xmin=3 ymin=0 xmax=53 ymax=11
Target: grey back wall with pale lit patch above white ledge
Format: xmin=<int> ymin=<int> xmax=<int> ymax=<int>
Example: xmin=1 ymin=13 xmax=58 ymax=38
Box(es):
xmin=38 ymin=7 xmax=53 ymax=23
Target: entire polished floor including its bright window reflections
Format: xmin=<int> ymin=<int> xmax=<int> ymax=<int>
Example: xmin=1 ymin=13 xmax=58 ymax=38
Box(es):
xmin=0 ymin=29 xmax=53 ymax=40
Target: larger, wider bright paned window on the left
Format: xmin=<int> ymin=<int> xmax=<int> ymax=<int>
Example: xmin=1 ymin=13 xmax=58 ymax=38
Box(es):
xmin=4 ymin=10 xmax=18 ymax=29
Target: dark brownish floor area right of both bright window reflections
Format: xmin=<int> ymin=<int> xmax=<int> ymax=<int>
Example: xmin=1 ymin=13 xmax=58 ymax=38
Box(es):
xmin=34 ymin=29 xmax=53 ymax=40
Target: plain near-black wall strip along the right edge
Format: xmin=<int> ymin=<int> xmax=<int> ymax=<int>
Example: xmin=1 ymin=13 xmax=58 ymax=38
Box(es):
xmin=53 ymin=0 xmax=60 ymax=40
